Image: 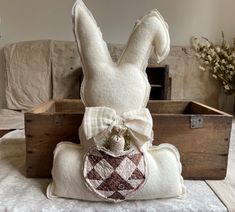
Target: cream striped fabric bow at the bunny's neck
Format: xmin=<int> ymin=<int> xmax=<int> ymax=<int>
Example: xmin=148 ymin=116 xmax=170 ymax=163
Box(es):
xmin=82 ymin=107 xmax=153 ymax=147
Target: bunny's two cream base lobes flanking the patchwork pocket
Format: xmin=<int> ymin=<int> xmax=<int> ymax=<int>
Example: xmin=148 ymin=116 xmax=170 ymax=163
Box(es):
xmin=47 ymin=142 xmax=185 ymax=201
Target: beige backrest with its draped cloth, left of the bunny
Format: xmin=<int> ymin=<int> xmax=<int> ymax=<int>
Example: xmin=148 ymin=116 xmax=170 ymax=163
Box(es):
xmin=3 ymin=40 xmax=81 ymax=110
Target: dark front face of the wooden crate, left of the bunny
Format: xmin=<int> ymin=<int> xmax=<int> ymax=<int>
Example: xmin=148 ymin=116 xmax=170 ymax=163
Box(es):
xmin=25 ymin=105 xmax=83 ymax=178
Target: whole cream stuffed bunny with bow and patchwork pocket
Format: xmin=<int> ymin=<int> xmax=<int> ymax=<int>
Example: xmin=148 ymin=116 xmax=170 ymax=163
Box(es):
xmin=47 ymin=0 xmax=185 ymax=202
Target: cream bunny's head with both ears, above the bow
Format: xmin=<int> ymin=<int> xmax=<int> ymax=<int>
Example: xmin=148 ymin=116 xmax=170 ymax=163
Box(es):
xmin=73 ymin=0 xmax=170 ymax=114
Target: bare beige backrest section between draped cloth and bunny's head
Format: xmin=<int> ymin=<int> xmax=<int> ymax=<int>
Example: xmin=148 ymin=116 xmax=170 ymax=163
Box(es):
xmin=51 ymin=41 xmax=82 ymax=99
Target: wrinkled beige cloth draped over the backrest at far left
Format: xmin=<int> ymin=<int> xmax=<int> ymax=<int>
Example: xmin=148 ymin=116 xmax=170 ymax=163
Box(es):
xmin=4 ymin=40 xmax=52 ymax=110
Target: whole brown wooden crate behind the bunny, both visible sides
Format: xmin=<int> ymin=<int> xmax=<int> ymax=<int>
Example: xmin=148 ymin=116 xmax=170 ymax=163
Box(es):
xmin=25 ymin=100 xmax=232 ymax=179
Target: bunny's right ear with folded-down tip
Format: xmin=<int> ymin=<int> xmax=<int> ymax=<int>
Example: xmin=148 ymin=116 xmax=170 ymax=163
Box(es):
xmin=119 ymin=9 xmax=170 ymax=70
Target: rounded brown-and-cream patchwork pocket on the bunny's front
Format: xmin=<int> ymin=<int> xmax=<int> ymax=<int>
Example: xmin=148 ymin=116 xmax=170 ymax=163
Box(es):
xmin=83 ymin=149 xmax=146 ymax=202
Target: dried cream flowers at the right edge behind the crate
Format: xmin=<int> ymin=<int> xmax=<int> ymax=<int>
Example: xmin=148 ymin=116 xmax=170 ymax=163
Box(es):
xmin=192 ymin=32 xmax=235 ymax=94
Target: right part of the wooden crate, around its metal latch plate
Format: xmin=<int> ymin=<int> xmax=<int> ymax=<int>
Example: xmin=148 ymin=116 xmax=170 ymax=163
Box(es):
xmin=148 ymin=101 xmax=232 ymax=179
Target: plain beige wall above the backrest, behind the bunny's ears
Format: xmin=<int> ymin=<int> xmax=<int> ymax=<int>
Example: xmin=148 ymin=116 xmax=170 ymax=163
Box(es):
xmin=0 ymin=0 xmax=235 ymax=112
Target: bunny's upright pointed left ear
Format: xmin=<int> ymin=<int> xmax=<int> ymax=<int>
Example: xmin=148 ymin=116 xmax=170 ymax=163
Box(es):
xmin=72 ymin=0 xmax=112 ymax=72
